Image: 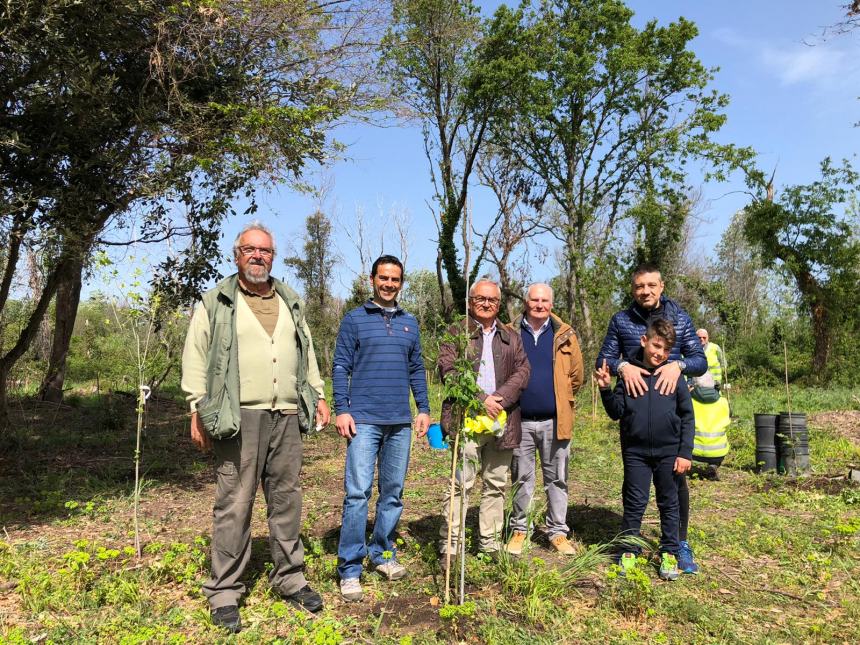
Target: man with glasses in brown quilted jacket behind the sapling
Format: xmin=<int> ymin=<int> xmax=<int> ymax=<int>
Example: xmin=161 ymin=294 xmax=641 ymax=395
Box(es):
xmin=438 ymin=280 xmax=529 ymax=566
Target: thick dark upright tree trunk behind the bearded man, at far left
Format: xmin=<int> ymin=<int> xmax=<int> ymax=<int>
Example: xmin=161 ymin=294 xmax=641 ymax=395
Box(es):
xmin=39 ymin=260 xmax=84 ymax=403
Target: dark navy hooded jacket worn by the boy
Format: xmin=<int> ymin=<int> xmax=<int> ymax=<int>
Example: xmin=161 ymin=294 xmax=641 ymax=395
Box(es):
xmin=600 ymin=349 xmax=696 ymax=459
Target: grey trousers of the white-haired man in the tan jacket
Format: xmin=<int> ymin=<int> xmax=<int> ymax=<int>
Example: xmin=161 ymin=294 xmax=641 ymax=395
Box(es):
xmin=510 ymin=419 xmax=570 ymax=539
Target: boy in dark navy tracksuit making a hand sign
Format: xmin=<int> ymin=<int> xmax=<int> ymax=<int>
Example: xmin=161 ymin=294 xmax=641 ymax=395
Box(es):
xmin=594 ymin=320 xmax=695 ymax=580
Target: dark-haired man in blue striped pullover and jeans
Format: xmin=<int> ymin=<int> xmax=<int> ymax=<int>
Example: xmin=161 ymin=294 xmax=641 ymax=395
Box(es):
xmin=332 ymin=255 xmax=430 ymax=601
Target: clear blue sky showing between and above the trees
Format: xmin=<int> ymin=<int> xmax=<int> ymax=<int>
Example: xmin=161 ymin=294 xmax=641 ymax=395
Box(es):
xmin=155 ymin=0 xmax=860 ymax=295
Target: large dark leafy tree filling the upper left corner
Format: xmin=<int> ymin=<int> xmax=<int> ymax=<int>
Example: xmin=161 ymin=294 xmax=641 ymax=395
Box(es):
xmin=0 ymin=0 xmax=376 ymax=418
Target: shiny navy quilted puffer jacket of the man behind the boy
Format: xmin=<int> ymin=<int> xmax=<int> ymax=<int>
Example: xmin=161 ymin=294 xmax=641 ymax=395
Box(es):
xmin=595 ymin=296 xmax=708 ymax=376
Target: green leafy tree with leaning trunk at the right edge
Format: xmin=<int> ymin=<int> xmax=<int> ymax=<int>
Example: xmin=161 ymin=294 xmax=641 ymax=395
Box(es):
xmin=744 ymin=158 xmax=860 ymax=380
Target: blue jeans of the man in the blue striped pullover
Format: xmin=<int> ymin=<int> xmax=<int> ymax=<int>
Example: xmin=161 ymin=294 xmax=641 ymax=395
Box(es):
xmin=337 ymin=423 xmax=412 ymax=580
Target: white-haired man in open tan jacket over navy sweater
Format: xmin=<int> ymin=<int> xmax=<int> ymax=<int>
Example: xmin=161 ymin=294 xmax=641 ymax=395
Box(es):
xmin=505 ymin=283 xmax=583 ymax=555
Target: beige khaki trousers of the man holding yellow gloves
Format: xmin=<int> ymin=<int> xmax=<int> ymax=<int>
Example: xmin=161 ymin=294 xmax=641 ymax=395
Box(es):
xmin=439 ymin=435 xmax=513 ymax=553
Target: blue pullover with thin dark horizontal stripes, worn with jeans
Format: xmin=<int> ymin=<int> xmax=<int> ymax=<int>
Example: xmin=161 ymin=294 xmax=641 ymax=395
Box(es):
xmin=332 ymin=300 xmax=430 ymax=425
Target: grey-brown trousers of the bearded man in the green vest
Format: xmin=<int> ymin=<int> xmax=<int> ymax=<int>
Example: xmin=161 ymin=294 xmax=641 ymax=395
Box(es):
xmin=203 ymin=408 xmax=307 ymax=609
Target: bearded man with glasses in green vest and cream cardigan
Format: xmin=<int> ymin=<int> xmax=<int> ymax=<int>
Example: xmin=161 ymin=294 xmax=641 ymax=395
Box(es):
xmin=182 ymin=222 xmax=330 ymax=633
